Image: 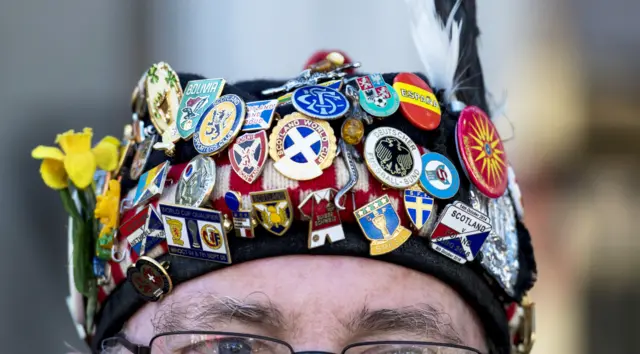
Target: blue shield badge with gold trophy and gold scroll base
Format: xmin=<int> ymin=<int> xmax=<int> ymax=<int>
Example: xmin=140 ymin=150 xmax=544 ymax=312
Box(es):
xmin=353 ymin=195 xmax=411 ymax=256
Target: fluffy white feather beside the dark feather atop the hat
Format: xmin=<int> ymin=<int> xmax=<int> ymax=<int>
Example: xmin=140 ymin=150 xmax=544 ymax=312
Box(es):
xmin=405 ymin=0 xmax=462 ymax=101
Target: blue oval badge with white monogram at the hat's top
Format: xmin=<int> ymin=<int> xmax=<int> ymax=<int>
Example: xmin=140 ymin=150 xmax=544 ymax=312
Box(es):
xmin=291 ymin=85 xmax=349 ymax=120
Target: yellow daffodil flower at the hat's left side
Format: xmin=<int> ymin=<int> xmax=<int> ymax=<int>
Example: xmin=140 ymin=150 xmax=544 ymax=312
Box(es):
xmin=31 ymin=128 xmax=120 ymax=189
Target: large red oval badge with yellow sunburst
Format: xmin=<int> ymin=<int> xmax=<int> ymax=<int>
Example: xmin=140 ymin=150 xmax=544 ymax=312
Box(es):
xmin=456 ymin=106 xmax=508 ymax=198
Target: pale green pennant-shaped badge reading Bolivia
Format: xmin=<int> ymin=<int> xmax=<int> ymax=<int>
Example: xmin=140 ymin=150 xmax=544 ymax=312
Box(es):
xmin=176 ymin=79 xmax=225 ymax=140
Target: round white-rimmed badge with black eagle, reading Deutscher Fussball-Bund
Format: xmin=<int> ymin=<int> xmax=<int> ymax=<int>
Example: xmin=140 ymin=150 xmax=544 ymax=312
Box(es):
xmin=364 ymin=127 xmax=422 ymax=189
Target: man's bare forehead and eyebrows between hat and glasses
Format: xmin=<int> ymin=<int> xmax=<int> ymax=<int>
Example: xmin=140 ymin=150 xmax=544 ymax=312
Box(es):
xmin=120 ymin=256 xmax=487 ymax=353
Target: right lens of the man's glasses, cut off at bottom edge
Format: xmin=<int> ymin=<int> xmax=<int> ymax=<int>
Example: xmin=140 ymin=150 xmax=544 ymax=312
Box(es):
xmin=344 ymin=342 xmax=478 ymax=354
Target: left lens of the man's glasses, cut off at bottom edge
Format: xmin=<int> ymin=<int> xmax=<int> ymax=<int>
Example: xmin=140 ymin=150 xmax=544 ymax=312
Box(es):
xmin=151 ymin=333 xmax=292 ymax=354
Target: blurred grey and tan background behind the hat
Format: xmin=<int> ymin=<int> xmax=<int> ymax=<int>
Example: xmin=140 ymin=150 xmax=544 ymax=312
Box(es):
xmin=0 ymin=0 xmax=640 ymax=354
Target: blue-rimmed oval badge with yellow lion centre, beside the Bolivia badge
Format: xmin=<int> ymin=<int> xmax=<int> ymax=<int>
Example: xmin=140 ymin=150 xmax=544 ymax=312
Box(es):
xmin=193 ymin=95 xmax=246 ymax=155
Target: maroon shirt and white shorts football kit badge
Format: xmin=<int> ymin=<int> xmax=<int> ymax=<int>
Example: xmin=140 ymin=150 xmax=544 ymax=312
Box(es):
xmin=298 ymin=188 xmax=344 ymax=249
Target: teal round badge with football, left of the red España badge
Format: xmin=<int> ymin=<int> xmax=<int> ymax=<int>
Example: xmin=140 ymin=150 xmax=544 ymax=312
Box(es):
xmin=356 ymin=74 xmax=400 ymax=118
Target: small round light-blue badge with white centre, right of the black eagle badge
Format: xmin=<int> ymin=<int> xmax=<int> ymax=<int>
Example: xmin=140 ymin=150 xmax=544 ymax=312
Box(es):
xmin=420 ymin=152 xmax=460 ymax=199
